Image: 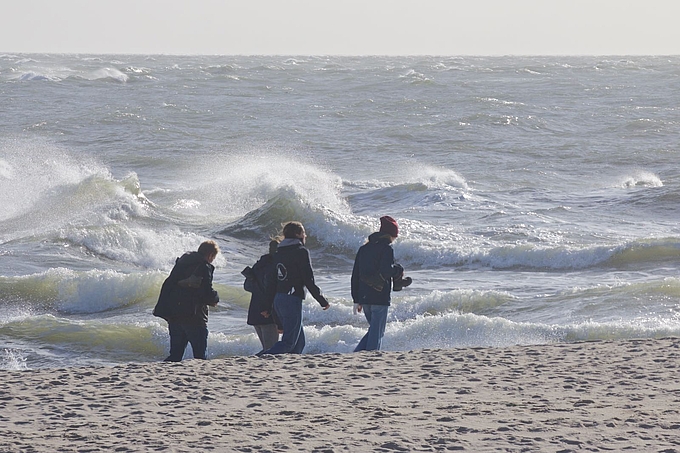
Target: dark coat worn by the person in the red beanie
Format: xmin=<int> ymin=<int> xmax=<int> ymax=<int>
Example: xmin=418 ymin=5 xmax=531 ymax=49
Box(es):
xmin=351 ymin=233 xmax=404 ymax=305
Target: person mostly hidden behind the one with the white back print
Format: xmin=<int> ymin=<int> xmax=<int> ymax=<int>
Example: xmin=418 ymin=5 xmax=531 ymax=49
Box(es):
xmin=243 ymin=240 xmax=279 ymax=351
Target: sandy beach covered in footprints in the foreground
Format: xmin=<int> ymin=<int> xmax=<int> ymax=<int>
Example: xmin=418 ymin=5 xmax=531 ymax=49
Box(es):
xmin=0 ymin=338 xmax=680 ymax=452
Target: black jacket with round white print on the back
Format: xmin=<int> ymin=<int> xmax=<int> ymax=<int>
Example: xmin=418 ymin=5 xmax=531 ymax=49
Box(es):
xmin=270 ymin=239 xmax=328 ymax=307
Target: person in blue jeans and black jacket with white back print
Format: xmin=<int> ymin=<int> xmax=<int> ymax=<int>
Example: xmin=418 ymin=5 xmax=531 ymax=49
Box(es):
xmin=259 ymin=222 xmax=330 ymax=355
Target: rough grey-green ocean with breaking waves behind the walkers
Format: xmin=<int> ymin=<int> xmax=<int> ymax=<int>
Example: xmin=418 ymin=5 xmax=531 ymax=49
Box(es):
xmin=0 ymin=54 xmax=680 ymax=369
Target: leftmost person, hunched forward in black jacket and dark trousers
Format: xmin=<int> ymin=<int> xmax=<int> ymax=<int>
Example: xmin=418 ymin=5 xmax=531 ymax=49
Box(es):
xmin=154 ymin=241 xmax=220 ymax=362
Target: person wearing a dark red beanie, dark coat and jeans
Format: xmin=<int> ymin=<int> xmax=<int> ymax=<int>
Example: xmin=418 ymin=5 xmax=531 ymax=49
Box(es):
xmin=351 ymin=216 xmax=411 ymax=352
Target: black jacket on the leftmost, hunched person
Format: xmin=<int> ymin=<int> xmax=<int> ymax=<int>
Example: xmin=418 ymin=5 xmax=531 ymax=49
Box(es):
xmin=154 ymin=252 xmax=220 ymax=325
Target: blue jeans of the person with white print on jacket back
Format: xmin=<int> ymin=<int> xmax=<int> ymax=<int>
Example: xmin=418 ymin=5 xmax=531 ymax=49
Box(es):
xmin=263 ymin=293 xmax=305 ymax=354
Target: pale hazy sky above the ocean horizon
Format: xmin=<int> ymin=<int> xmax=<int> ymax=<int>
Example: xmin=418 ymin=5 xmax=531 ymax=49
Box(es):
xmin=0 ymin=0 xmax=680 ymax=56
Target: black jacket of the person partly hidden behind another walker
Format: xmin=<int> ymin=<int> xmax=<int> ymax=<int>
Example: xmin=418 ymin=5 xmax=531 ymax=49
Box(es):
xmin=244 ymin=254 xmax=276 ymax=326
